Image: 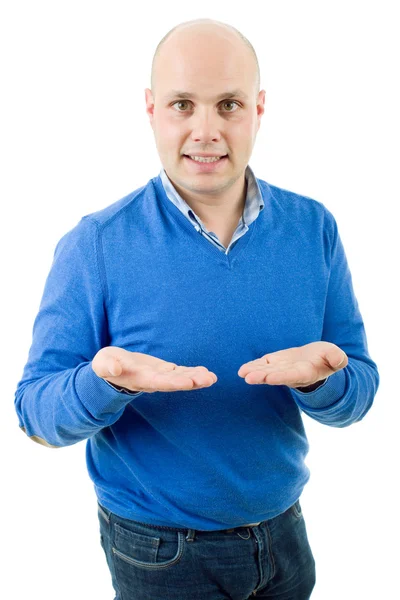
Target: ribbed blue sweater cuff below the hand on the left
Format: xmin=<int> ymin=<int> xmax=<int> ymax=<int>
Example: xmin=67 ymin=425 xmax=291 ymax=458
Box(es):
xmin=75 ymin=362 xmax=143 ymax=418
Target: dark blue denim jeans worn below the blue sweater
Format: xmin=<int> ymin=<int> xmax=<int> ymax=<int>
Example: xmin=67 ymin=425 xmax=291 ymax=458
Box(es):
xmin=98 ymin=500 xmax=315 ymax=600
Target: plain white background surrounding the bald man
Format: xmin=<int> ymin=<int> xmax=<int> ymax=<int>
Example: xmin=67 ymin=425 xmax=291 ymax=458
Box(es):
xmin=0 ymin=0 xmax=400 ymax=600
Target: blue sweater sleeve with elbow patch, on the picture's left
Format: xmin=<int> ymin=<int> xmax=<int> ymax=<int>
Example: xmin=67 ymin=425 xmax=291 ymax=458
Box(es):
xmin=15 ymin=216 xmax=141 ymax=447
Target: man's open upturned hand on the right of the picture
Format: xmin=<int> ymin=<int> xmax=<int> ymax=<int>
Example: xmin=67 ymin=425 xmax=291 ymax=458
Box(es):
xmin=238 ymin=342 xmax=349 ymax=388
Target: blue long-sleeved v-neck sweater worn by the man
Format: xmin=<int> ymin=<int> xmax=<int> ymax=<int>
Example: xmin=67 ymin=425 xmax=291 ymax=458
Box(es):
xmin=15 ymin=170 xmax=379 ymax=530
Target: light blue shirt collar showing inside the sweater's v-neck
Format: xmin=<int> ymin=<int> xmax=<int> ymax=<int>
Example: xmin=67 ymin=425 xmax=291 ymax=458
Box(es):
xmin=160 ymin=165 xmax=264 ymax=254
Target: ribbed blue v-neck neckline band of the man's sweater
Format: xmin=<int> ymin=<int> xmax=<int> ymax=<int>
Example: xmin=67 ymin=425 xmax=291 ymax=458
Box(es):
xmin=152 ymin=177 xmax=261 ymax=267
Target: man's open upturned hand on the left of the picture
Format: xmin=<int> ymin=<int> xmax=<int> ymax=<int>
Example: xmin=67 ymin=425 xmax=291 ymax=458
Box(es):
xmin=92 ymin=346 xmax=218 ymax=394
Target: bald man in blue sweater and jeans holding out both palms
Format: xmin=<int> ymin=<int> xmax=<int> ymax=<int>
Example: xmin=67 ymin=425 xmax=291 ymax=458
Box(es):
xmin=16 ymin=19 xmax=379 ymax=600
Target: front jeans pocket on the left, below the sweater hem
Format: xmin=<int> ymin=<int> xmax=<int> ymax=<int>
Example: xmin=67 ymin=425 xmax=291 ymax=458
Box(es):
xmin=112 ymin=523 xmax=184 ymax=575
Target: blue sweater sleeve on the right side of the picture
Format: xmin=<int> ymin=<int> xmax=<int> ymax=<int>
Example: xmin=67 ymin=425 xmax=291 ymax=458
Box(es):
xmin=290 ymin=208 xmax=379 ymax=427
